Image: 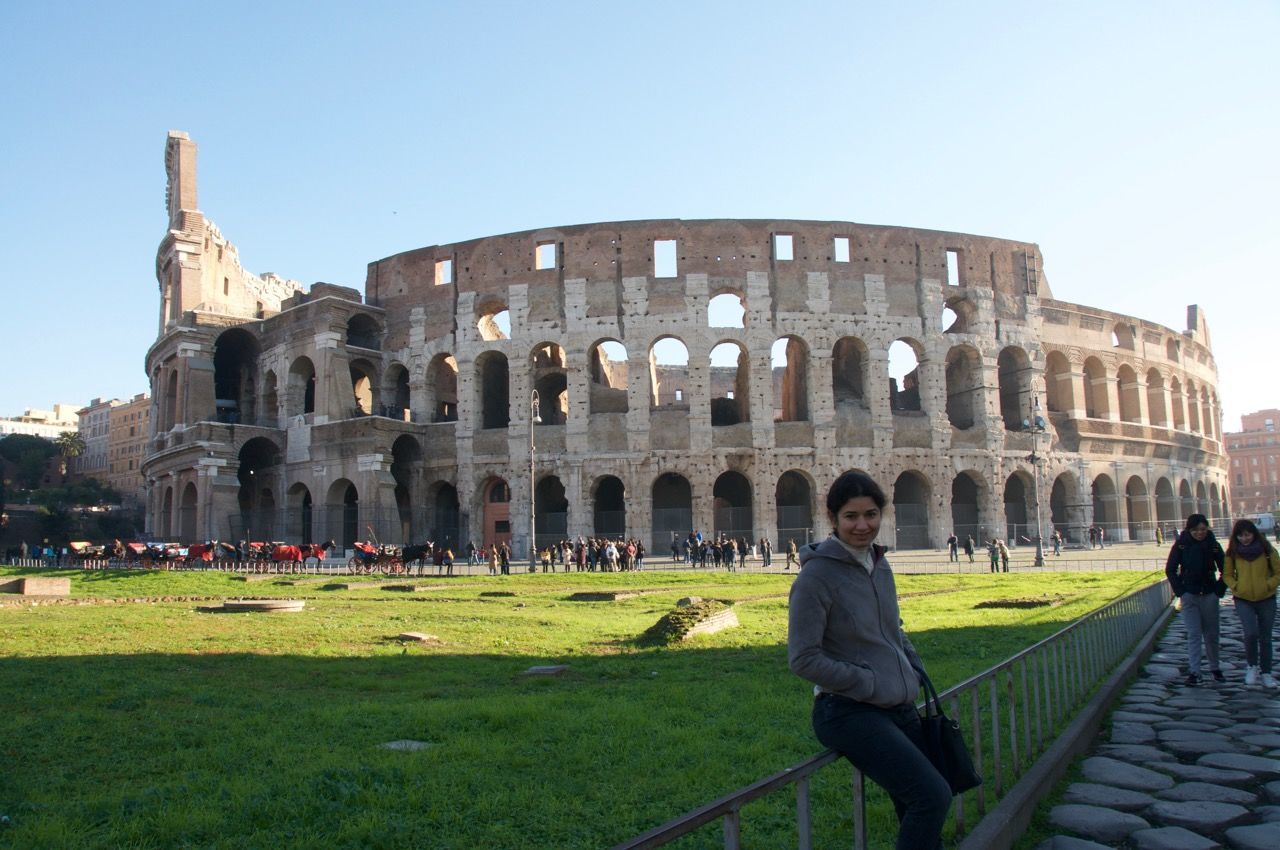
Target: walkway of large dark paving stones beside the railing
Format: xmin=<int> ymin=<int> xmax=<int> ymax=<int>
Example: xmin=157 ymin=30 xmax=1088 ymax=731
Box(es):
xmin=1037 ymin=599 xmax=1280 ymax=850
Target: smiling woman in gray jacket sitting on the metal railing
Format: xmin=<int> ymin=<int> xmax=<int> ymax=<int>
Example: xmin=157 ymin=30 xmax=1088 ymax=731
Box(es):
xmin=787 ymin=472 xmax=951 ymax=850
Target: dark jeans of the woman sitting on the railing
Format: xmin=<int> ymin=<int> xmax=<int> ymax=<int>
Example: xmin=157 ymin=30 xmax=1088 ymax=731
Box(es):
xmin=813 ymin=694 xmax=951 ymax=850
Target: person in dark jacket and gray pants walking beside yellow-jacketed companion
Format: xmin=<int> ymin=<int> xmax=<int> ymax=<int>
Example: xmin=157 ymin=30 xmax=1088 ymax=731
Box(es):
xmin=1165 ymin=513 xmax=1226 ymax=687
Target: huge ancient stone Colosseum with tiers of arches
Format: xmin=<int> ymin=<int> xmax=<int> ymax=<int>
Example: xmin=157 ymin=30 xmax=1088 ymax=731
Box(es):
xmin=143 ymin=132 xmax=1228 ymax=557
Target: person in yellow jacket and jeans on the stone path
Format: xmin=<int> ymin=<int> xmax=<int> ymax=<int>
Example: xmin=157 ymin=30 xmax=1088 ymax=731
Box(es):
xmin=1222 ymin=520 xmax=1280 ymax=687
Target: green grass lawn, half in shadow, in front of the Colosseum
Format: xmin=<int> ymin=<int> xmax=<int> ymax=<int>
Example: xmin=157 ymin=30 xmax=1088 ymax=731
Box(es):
xmin=0 ymin=568 xmax=1157 ymax=849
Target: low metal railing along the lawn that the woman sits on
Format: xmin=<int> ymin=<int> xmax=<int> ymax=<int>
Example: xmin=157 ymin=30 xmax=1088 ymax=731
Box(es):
xmin=613 ymin=580 xmax=1171 ymax=850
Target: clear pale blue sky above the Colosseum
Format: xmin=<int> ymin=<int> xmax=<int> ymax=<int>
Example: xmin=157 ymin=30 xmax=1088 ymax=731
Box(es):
xmin=0 ymin=0 xmax=1280 ymax=429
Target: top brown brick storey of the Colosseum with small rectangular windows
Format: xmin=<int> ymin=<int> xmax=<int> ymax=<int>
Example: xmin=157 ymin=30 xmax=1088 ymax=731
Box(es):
xmin=365 ymin=219 xmax=1052 ymax=338
